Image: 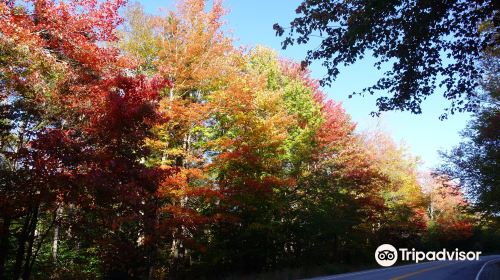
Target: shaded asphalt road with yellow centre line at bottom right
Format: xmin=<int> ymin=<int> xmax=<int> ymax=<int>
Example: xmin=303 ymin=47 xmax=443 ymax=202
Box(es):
xmin=311 ymin=255 xmax=500 ymax=280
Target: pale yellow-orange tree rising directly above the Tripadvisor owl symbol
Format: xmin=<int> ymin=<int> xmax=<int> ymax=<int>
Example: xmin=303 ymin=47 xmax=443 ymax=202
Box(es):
xmin=362 ymin=130 xmax=428 ymax=246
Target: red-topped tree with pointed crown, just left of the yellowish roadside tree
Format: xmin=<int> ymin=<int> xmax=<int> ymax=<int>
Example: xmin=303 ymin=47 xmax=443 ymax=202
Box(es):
xmin=290 ymin=91 xmax=386 ymax=265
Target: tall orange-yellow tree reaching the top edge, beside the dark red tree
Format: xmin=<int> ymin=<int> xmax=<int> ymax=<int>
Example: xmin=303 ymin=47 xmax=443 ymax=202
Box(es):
xmin=120 ymin=0 xmax=241 ymax=273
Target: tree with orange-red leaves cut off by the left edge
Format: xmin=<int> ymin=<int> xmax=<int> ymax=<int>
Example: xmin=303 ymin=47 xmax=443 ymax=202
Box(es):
xmin=0 ymin=19 xmax=64 ymax=277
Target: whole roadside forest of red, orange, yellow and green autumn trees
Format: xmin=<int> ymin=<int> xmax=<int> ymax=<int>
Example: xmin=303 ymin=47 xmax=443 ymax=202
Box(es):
xmin=0 ymin=0 xmax=500 ymax=280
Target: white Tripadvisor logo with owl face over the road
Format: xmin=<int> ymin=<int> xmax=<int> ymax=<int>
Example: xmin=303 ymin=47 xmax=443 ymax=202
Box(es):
xmin=375 ymin=244 xmax=481 ymax=266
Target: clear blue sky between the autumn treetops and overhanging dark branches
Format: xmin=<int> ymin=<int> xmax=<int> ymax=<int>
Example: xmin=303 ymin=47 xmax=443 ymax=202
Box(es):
xmin=139 ymin=0 xmax=470 ymax=168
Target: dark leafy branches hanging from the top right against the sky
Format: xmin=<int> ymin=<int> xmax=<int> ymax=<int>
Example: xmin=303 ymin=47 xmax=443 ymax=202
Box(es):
xmin=274 ymin=0 xmax=498 ymax=116
